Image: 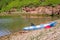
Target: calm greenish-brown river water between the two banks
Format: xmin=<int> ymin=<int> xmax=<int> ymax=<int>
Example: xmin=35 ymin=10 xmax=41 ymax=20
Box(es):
xmin=0 ymin=17 xmax=58 ymax=36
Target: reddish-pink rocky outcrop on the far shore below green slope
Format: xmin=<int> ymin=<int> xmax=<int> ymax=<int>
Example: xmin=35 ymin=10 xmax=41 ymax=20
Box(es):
xmin=22 ymin=5 xmax=60 ymax=14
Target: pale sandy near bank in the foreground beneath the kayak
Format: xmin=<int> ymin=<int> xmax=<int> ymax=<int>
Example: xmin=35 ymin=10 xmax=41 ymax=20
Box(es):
xmin=0 ymin=19 xmax=60 ymax=40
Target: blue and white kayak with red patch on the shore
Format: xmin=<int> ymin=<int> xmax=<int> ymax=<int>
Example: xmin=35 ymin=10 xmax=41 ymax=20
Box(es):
xmin=23 ymin=21 xmax=57 ymax=30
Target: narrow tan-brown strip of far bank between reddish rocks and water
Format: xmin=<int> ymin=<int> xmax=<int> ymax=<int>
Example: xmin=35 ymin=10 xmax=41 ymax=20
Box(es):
xmin=0 ymin=12 xmax=60 ymax=18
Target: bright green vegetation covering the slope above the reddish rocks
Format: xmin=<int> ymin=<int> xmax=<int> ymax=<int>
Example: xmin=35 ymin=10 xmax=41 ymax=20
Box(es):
xmin=0 ymin=0 xmax=60 ymax=12
